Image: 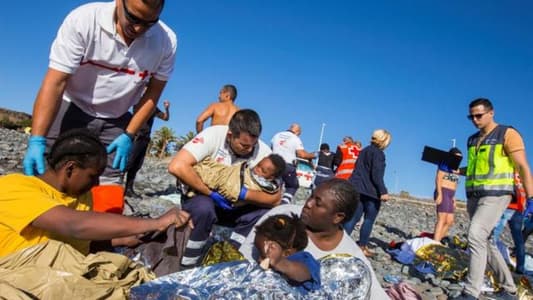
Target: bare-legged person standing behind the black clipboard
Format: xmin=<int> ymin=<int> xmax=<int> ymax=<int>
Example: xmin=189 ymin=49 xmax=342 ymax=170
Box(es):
xmin=433 ymin=147 xmax=463 ymax=242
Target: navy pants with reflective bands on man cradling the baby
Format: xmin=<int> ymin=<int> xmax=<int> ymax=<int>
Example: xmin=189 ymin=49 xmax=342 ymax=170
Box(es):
xmin=182 ymin=195 xmax=269 ymax=266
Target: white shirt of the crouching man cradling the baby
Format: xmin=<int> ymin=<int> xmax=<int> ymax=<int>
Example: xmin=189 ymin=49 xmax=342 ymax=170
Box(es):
xmin=183 ymin=125 xmax=272 ymax=168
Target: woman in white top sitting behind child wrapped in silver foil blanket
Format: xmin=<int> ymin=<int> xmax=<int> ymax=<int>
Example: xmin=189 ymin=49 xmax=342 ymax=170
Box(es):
xmin=239 ymin=178 xmax=389 ymax=300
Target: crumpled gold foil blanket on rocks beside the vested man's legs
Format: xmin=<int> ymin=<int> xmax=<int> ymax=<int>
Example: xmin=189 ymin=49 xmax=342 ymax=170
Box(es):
xmin=415 ymin=244 xmax=470 ymax=280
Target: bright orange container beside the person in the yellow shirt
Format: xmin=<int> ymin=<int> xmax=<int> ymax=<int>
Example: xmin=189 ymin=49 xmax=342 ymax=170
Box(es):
xmin=91 ymin=185 xmax=124 ymax=214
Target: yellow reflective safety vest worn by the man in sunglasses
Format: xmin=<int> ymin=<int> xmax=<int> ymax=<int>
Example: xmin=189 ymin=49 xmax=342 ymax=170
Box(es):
xmin=466 ymin=125 xmax=514 ymax=197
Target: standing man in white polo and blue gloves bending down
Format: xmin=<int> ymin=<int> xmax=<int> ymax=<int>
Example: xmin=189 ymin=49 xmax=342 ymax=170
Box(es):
xmin=23 ymin=0 xmax=177 ymax=191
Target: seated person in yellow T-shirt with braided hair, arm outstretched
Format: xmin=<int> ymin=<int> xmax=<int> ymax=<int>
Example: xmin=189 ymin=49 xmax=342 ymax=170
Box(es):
xmin=0 ymin=129 xmax=192 ymax=257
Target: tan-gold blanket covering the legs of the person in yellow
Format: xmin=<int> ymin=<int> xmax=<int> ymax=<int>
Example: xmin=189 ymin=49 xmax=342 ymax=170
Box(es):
xmin=0 ymin=240 xmax=155 ymax=300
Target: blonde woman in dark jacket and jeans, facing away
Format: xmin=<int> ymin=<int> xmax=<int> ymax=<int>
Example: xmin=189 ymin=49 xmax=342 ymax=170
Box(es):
xmin=344 ymin=129 xmax=391 ymax=256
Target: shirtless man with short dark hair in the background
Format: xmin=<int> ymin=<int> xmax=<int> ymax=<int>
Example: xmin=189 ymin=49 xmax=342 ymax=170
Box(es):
xmin=196 ymin=84 xmax=239 ymax=133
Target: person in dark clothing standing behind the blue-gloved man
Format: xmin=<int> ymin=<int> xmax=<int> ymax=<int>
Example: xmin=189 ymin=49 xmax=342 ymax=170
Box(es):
xmin=124 ymin=100 xmax=170 ymax=198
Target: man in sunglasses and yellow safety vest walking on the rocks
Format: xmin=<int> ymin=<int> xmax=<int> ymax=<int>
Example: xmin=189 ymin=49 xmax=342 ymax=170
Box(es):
xmin=453 ymin=98 xmax=533 ymax=299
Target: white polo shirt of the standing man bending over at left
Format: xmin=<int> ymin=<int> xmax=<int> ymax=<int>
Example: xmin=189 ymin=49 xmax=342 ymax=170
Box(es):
xmin=49 ymin=2 xmax=177 ymax=118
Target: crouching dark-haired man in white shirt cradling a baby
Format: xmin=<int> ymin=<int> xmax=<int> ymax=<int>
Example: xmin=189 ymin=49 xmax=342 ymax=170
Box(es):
xmin=168 ymin=109 xmax=281 ymax=267
